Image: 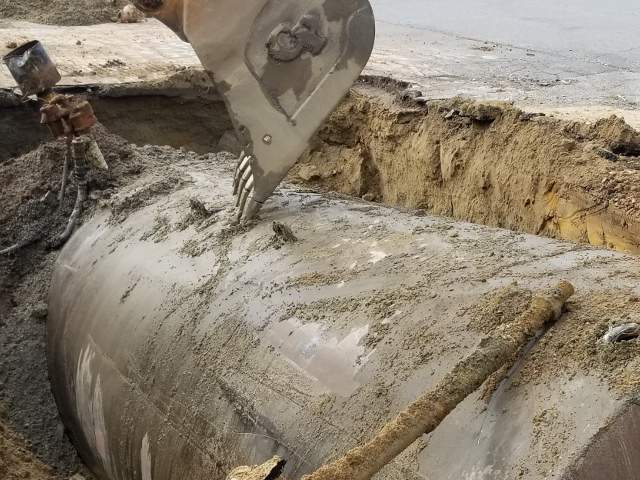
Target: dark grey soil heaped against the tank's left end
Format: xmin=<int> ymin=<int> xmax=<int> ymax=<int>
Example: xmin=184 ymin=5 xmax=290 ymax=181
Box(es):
xmin=0 ymin=127 xmax=175 ymax=478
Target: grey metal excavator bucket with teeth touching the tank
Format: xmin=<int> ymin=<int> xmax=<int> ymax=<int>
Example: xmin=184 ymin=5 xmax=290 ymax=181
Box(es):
xmin=137 ymin=0 xmax=375 ymax=221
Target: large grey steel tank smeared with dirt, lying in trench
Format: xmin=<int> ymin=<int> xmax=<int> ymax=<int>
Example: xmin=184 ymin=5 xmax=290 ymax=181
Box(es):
xmin=48 ymin=158 xmax=640 ymax=480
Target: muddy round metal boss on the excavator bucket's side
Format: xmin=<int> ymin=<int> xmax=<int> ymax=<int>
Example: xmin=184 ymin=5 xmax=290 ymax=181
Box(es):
xmin=267 ymin=14 xmax=327 ymax=62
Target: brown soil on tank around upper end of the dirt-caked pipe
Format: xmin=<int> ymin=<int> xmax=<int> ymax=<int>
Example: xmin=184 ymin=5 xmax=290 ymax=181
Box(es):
xmin=460 ymin=286 xmax=640 ymax=396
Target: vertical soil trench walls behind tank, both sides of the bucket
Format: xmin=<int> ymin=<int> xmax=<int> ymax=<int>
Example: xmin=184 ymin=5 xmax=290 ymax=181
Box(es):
xmin=0 ymin=78 xmax=640 ymax=253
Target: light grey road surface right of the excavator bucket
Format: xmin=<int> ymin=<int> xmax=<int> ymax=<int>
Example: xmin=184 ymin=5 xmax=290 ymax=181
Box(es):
xmin=370 ymin=0 xmax=640 ymax=118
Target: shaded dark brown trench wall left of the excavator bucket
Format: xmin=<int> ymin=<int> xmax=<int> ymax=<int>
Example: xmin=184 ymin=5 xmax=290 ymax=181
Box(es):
xmin=0 ymin=69 xmax=237 ymax=163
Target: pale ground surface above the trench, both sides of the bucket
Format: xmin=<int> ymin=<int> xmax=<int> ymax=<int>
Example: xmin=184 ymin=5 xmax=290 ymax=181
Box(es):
xmin=0 ymin=0 xmax=640 ymax=123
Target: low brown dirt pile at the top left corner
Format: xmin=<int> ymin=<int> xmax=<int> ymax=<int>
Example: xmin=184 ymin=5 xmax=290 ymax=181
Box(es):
xmin=0 ymin=0 xmax=128 ymax=25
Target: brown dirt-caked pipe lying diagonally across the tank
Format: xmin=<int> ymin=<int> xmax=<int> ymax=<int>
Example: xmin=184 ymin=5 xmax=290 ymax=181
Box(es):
xmin=234 ymin=282 xmax=575 ymax=480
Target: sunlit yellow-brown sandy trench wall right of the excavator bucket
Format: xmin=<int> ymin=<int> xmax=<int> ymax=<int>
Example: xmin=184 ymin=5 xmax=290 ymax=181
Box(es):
xmin=290 ymin=79 xmax=640 ymax=253
